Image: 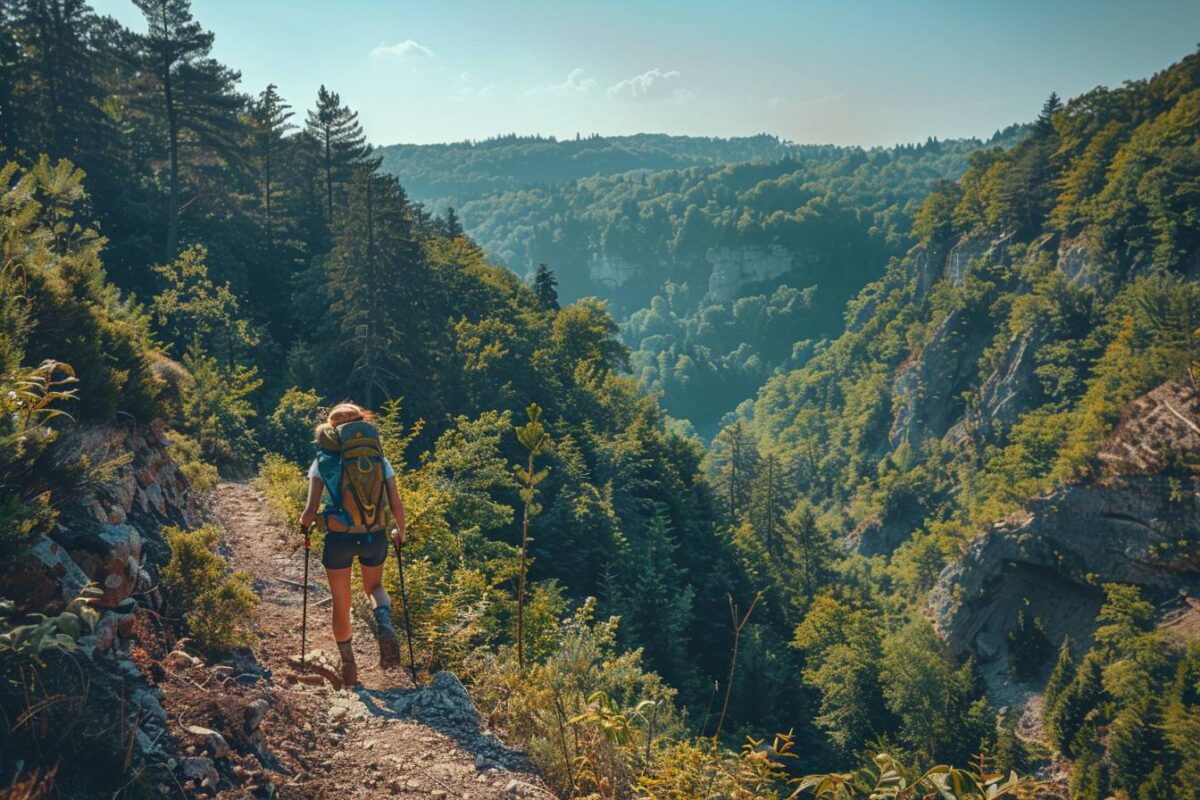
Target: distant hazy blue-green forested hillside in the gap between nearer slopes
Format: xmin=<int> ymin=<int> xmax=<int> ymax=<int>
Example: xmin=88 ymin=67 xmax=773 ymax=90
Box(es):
xmin=380 ymin=133 xmax=1025 ymax=435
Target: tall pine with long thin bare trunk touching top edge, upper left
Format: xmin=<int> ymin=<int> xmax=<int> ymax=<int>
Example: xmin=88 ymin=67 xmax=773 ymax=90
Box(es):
xmin=133 ymin=0 xmax=241 ymax=263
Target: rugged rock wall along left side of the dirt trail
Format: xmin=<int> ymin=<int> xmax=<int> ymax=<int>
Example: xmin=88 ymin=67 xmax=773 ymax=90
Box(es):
xmin=0 ymin=423 xmax=203 ymax=786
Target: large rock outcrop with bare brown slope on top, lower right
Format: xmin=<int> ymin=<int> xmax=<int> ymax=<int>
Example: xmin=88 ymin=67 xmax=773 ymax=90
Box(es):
xmin=930 ymin=381 xmax=1200 ymax=663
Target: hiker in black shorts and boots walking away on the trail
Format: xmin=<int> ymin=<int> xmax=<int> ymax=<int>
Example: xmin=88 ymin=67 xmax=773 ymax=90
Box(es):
xmin=300 ymin=403 xmax=404 ymax=686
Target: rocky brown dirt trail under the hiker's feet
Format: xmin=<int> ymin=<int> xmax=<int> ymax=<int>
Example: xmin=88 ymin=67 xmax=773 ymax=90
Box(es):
xmin=157 ymin=482 xmax=553 ymax=800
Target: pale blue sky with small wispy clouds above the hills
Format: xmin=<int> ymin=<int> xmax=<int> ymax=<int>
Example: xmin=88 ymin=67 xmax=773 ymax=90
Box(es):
xmin=91 ymin=0 xmax=1200 ymax=146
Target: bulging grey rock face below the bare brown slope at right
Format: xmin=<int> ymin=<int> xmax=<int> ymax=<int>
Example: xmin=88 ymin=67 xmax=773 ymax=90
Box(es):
xmin=930 ymin=475 xmax=1200 ymax=660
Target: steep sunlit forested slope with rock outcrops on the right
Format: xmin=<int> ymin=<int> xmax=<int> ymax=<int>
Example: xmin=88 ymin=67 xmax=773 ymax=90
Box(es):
xmin=712 ymin=55 xmax=1200 ymax=799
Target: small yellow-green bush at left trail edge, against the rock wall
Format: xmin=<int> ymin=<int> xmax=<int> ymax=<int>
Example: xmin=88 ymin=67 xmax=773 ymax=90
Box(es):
xmin=162 ymin=525 xmax=258 ymax=650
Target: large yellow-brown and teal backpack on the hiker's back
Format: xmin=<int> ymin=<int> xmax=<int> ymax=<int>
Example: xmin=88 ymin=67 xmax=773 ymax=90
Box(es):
xmin=317 ymin=420 xmax=388 ymax=534
